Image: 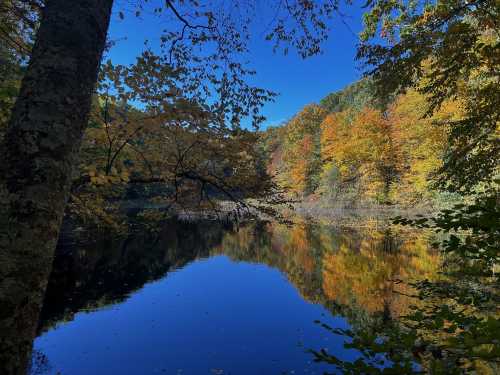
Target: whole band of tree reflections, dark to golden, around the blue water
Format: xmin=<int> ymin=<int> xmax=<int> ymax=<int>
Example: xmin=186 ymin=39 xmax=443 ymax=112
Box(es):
xmin=33 ymin=220 xmax=439 ymax=369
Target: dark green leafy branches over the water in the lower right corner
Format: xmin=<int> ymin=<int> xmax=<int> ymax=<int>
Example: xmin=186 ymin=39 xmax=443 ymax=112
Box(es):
xmin=313 ymin=189 xmax=500 ymax=374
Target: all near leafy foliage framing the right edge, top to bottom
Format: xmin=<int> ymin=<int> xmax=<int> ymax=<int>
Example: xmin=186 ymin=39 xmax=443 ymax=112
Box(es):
xmin=313 ymin=0 xmax=500 ymax=374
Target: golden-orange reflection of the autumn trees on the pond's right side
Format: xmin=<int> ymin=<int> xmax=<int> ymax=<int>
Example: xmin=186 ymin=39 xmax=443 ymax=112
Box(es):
xmin=212 ymin=223 xmax=440 ymax=317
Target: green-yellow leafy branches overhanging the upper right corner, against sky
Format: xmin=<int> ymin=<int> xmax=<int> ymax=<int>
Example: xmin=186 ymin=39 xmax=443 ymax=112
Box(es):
xmin=358 ymin=0 xmax=500 ymax=192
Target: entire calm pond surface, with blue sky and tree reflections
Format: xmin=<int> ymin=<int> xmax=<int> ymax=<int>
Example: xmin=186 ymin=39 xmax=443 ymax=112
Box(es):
xmin=32 ymin=221 xmax=437 ymax=374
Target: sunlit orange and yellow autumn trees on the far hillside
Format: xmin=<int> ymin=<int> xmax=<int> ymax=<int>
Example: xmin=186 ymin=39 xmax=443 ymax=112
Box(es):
xmin=261 ymin=79 xmax=461 ymax=207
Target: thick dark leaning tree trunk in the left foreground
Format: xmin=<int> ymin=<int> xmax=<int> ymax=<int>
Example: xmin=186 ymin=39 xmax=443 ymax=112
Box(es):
xmin=0 ymin=0 xmax=113 ymax=374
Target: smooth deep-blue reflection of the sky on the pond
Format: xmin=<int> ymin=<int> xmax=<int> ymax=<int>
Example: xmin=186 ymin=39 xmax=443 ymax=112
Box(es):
xmin=35 ymin=256 xmax=354 ymax=375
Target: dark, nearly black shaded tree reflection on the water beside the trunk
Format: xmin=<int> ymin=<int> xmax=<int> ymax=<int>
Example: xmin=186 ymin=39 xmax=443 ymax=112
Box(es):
xmin=38 ymin=220 xmax=232 ymax=332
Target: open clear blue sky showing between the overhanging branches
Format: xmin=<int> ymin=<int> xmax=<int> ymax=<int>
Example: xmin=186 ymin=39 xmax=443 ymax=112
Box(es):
xmin=108 ymin=2 xmax=368 ymax=127
